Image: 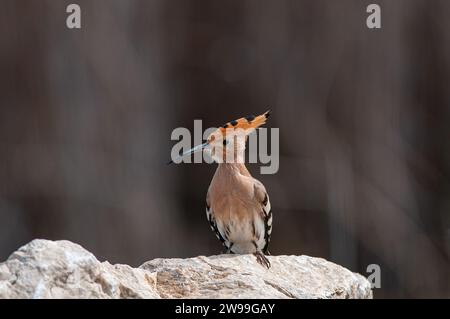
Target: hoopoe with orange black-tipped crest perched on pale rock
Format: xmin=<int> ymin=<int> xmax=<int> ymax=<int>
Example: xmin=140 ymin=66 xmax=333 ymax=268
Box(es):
xmin=171 ymin=111 xmax=272 ymax=268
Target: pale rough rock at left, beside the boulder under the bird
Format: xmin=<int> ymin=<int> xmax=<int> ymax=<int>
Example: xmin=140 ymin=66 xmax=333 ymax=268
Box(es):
xmin=0 ymin=240 xmax=159 ymax=298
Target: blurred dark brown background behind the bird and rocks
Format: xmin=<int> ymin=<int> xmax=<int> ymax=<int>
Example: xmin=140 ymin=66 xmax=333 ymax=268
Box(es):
xmin=0 ymin=0 xmax=450 ymax=297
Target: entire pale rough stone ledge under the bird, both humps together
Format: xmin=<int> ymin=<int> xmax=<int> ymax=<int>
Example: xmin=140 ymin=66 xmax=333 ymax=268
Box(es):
xmin=0 ymin=240 xmax=372 ymax=298
